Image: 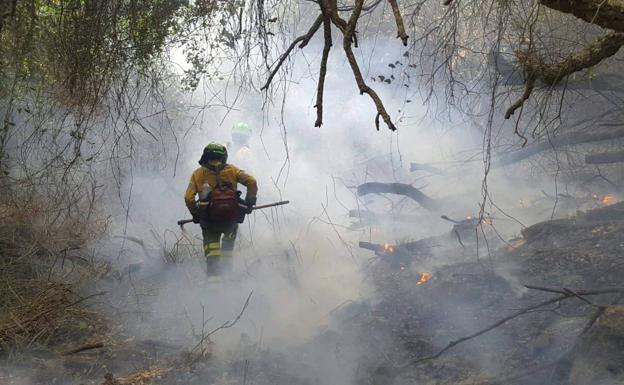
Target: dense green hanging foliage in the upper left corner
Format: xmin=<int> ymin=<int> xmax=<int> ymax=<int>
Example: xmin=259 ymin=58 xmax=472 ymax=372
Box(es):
xmin=0 ymin=0 xmax=189 ymax=105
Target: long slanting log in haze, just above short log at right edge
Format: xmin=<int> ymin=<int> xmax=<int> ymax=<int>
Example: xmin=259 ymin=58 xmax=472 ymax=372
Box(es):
xmin=495 ymin=126 xmax=624 ymax=166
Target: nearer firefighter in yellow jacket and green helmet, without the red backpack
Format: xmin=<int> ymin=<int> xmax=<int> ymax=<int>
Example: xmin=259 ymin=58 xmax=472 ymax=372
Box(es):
xmin=184 ymin=143 xmax=258 ymax=275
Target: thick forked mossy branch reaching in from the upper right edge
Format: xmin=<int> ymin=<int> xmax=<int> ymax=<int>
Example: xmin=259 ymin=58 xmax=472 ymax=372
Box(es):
xmin=505 ymin=33 xmax=624 ymax=119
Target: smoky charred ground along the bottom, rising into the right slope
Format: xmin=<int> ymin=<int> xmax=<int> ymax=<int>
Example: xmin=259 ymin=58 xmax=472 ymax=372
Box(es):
xmin=0 ymin=203 xmax=624 ymax=385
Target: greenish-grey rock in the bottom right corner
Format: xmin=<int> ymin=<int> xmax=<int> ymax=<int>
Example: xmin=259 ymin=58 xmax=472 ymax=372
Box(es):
xmin=569 ymin=306 xmax=624 ymax=385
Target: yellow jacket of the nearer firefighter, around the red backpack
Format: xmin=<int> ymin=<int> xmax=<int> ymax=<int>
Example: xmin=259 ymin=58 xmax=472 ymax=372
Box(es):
xmin=184 ymin=161 xmax=258 ymax=216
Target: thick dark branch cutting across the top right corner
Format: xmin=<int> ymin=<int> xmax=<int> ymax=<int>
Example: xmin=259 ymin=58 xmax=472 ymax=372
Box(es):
xmin=540 ymin=0 xmax=624 ymax=32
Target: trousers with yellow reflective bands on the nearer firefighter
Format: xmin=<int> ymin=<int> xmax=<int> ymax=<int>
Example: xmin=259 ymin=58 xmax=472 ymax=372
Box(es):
xmin=201 ymin=223 xmax=238 ymax=275
